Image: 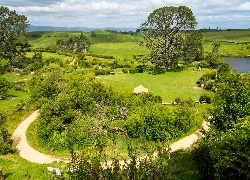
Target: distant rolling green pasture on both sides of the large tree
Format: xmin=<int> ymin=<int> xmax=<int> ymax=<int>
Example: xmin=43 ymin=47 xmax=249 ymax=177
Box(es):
xmin=30 ymin=30 xmax=250 ymax=60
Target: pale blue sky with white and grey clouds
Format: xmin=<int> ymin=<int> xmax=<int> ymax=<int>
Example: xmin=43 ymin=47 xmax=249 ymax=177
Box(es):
xmin=0 ymin=0 xmax=250 ymax=29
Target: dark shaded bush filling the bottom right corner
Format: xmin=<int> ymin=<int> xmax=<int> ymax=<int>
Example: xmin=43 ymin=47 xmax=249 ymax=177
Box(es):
xmin=191 ymin=118 xmax=250 ymax=179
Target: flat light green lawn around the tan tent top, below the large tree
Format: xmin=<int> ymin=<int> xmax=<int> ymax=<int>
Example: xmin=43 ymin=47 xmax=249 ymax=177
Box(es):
xmin=96 ymin=68 xmax=214 ymax=102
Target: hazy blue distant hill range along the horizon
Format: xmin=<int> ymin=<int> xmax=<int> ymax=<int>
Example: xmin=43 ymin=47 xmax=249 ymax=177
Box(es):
xmin=28 ymin=25 xmax=137 ymax=32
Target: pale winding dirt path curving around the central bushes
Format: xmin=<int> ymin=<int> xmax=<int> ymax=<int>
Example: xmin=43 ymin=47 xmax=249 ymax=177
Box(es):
xmin=12 ymin=110 xmax=208 ymax=165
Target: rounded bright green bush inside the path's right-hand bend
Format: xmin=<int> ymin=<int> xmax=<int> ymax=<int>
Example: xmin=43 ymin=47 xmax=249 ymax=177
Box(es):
xmin=124 ymin=103 xmax=194 ymax=141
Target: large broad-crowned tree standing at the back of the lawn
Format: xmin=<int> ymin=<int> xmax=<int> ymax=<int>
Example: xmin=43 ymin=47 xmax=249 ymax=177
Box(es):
xmin=140 ymin=6 xmax=201 ymax=69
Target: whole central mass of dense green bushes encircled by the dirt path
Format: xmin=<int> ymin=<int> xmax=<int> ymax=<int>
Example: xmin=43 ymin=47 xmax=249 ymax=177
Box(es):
xmin=30 ymin=69 xmax=198 ymax=153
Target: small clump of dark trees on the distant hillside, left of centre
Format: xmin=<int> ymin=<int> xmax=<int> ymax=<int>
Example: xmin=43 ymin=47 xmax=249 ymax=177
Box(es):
xmin=56 ymin=33 xmax=90 ymax=53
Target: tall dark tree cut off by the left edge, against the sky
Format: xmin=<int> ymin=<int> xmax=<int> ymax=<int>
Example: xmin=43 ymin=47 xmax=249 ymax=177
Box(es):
xmin=0 ymin=6 xmax=29 ymax=68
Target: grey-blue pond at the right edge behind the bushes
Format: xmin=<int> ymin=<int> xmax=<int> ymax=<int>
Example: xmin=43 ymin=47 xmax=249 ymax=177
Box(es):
xmin=224 ymin=57 xmax=250 ymax=73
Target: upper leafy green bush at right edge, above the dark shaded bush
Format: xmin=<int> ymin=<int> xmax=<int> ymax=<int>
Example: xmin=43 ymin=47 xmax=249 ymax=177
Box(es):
xmin=211 ymin=73 xmax=250 ymax=131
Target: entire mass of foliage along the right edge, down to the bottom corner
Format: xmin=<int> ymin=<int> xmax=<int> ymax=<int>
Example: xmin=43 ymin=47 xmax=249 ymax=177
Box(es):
xmin=192 ymin=71 xmax=250 ymax=179
